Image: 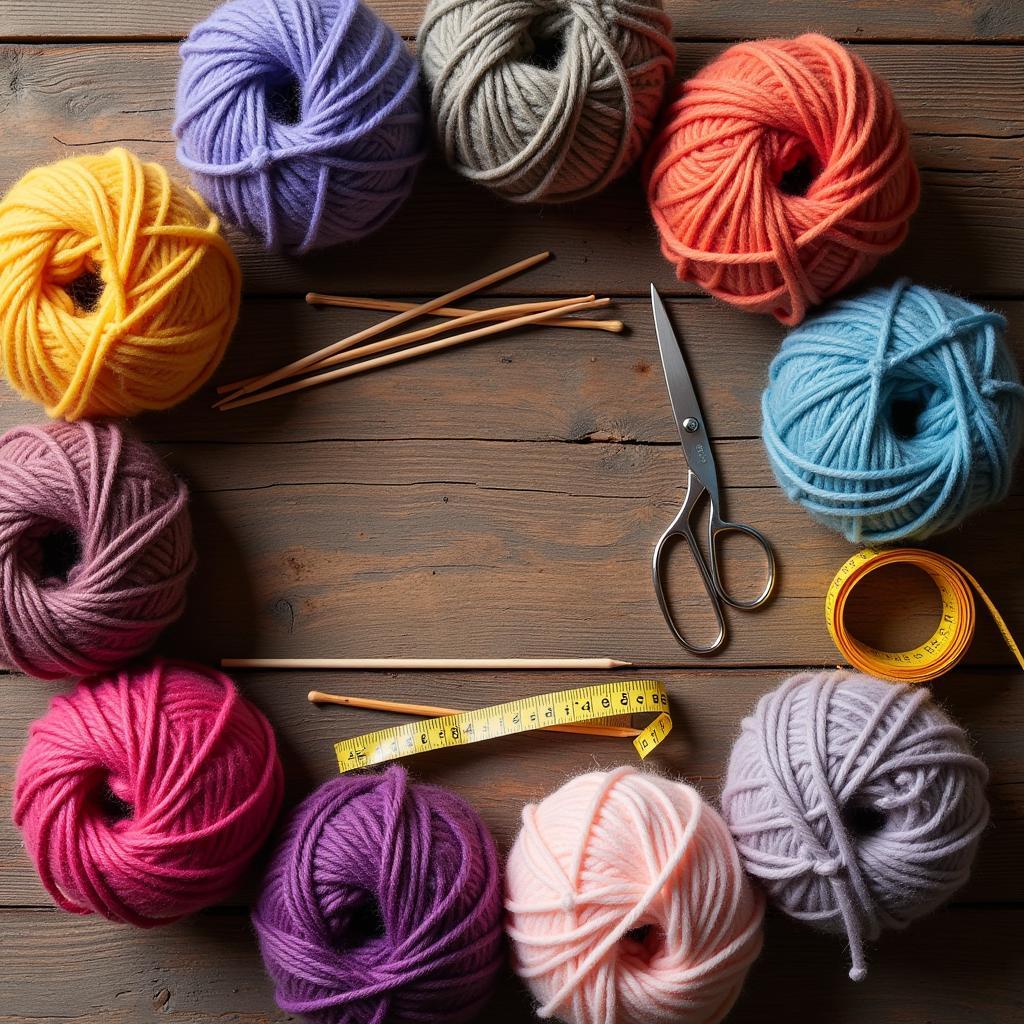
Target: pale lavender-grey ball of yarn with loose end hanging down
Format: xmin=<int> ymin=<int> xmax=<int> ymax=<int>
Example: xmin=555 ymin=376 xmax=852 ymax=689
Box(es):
xmin=722 ymin=672 xmax=988 ymax=981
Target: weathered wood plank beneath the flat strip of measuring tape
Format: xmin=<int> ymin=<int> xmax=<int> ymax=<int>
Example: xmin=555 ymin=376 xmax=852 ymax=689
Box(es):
xmin=0 ymin=667 xmax=1024 ymax=909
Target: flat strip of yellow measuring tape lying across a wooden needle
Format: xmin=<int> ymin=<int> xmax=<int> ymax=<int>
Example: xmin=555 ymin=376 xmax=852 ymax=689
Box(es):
xmin=334 ymin=679 xmax=672 ymax=773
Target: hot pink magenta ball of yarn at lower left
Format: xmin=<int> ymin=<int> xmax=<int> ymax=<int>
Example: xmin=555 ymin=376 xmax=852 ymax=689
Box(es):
xmin=14 ymin=660 xmax=283 ymax=928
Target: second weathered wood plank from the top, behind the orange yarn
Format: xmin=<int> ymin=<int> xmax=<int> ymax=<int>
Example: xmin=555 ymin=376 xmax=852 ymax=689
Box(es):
xmin=0 ymin=44 xmax=1024 ymax=295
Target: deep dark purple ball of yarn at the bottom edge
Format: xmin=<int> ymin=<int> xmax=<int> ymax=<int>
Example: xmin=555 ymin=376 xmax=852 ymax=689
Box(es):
xmin=253 ymin=765 xmax=502 ymax=1024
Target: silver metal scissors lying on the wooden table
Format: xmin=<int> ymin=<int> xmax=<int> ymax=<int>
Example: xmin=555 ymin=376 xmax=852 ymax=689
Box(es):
xmin=650 ymin=285 xmax=775 ymax=654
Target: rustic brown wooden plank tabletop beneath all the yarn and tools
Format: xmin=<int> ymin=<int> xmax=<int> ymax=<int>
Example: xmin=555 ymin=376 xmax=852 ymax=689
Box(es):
xmin=0 ymin=0 xmax=1024 ymax=1024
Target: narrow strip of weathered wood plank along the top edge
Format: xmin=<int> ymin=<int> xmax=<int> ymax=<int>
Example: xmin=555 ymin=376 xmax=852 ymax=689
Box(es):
xmin=0 ymin=0 xmax=1024 ymax=40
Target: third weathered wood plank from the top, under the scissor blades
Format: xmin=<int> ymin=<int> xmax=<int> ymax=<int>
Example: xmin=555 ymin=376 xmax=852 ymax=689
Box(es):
xmin=86 ymin=292 xmax=1024 ymax=444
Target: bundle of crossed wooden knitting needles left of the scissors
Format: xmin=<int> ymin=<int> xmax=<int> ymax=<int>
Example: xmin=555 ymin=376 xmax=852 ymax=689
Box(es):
xmin=214 ymin=252 xmax=623 ymax=412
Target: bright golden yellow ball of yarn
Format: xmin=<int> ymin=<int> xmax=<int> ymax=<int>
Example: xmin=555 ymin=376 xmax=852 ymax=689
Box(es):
xmin=0 ymin=150 xmax=242 ymax=420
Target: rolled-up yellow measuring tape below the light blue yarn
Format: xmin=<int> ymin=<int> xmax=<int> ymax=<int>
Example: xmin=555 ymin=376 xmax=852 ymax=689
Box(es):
xmin=825 ymin=548 xmax=1024 ymax=683
